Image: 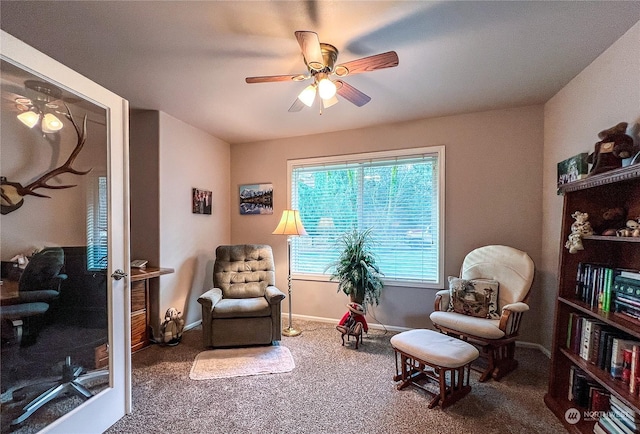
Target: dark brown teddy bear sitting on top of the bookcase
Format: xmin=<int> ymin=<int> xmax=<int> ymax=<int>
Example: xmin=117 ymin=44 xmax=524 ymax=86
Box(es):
xmin=587 ymin=122 xmax=637 ymax=176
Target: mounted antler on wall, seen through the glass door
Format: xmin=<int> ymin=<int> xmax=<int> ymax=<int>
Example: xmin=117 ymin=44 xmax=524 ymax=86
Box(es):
xmin=0 ymin=104 xmax=91 ymax=214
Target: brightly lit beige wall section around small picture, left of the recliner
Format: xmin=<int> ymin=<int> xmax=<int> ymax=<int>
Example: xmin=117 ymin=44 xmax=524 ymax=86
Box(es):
xmin=159 ymin=112 xmax=231 ymax=332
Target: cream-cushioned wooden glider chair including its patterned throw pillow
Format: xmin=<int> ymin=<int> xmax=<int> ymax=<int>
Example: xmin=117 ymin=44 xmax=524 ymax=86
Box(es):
xmin=430 ymin=245 xmax=535 ymax=381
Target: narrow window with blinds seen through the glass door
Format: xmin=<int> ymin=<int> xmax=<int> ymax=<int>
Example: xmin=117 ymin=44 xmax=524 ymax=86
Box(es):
xmin=87 ymin=176 xmax=109 ymax=271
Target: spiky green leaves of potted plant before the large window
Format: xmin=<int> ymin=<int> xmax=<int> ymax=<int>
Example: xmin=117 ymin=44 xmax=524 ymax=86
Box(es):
xmin=327 ymin=228 xmax=384 ymax=311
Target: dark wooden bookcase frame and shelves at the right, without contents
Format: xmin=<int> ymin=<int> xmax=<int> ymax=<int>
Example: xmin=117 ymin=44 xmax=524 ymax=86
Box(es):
xmin=545 ymin=164 xmax=640 ymax=433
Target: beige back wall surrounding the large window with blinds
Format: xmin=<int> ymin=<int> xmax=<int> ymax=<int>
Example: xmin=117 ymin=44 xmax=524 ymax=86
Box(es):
xmin=231 ymin=106 xmax=543 ymax=341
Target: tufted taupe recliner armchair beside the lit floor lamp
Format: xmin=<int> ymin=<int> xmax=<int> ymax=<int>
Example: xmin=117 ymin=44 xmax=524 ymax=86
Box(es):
xmin=198 ymin=244 xmax=285 ymax=347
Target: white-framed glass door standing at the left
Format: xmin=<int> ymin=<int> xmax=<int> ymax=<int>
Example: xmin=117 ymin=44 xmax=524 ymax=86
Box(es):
xmin=0 ymin=33 xmax=130 ymax=433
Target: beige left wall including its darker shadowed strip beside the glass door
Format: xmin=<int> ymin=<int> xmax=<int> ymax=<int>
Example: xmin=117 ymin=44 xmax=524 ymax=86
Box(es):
xmin=130 ymin=111 xmax=230 ymax=336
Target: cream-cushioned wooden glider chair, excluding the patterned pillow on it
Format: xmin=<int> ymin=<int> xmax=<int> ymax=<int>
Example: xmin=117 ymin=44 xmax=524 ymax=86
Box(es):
xmin=430 ymin=246 xmax=535 ymax=381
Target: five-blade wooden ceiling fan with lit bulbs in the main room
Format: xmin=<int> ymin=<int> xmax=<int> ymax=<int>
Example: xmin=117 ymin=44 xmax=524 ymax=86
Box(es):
xmin=245 ymin=31 xmax=398 ymax=113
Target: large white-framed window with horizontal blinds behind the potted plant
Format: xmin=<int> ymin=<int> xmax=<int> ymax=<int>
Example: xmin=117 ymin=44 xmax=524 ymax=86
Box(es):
xmin=288 ymin=146 xmax=444 ymax=288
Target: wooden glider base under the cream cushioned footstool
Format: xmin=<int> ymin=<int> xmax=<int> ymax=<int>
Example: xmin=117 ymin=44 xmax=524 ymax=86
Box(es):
xmin=393 ymin=348 xmax=471 ymax=409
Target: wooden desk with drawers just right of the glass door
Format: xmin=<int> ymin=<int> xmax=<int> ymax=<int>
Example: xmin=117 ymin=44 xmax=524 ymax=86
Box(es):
xmin=131 ymin=267 xmax=174 ymax=353
